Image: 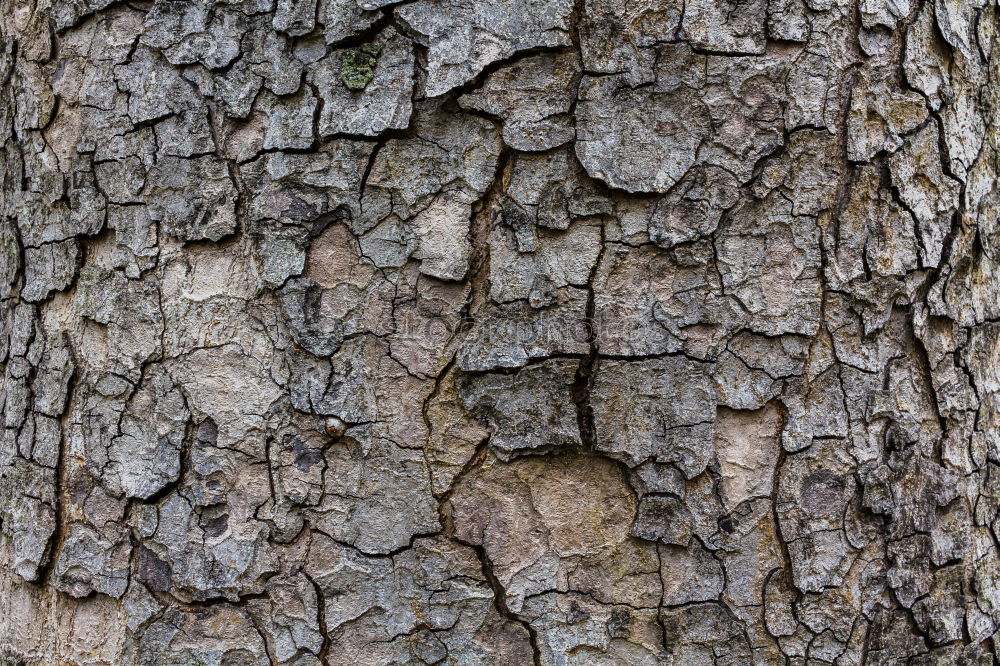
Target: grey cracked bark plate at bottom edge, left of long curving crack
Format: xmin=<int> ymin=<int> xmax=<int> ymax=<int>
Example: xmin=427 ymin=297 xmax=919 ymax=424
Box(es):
xmin=306 ymin=535 xmax=531 ymax=663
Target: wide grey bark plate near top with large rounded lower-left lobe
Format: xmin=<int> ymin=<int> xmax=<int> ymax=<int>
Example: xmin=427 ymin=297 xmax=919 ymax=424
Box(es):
xmin=576 ymin=44 xmax=787 ymax=193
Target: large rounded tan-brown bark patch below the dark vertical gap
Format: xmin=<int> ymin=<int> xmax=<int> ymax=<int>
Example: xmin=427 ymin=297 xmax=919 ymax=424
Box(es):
xmin=447 ymin=454 xmax=660 ymax=612
